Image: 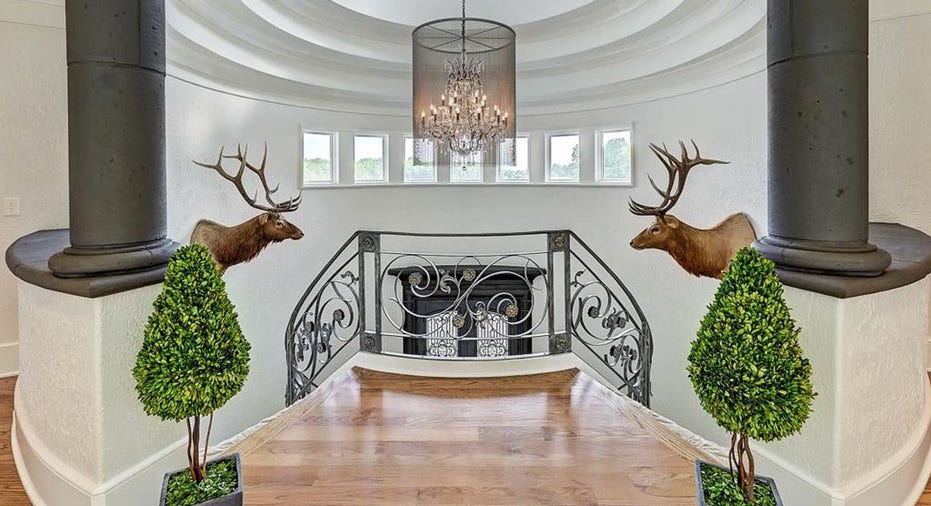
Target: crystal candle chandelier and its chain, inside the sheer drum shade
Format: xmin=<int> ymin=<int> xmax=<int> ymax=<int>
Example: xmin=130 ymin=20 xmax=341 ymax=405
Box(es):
xmin=415 ymin=1 xmax=513 ymax=161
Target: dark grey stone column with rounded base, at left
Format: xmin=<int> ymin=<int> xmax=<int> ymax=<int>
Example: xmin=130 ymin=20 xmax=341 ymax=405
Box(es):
xmin=48 ymin=0 xmax=175 ymax=277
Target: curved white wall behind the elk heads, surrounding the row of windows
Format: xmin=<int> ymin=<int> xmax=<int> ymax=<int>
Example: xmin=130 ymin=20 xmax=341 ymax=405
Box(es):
xmin=167 ymin=74 xmax=766 ymax=446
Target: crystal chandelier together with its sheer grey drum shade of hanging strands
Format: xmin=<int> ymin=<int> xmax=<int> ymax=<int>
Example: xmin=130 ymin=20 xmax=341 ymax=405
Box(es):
xmin=413 ymin=0 xmax=516 ymax=163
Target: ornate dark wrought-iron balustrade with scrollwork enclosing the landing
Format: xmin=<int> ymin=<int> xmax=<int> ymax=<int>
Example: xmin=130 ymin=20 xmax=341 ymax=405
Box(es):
xmin=285 ymin=230 xmax=653 ymax=406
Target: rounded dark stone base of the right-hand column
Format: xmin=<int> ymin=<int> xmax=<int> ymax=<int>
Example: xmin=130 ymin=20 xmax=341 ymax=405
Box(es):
xmin=753 ymin=235 xmax=892 ymax=277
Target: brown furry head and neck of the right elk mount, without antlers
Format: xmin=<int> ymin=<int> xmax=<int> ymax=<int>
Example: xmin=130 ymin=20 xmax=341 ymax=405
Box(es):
xmin=630 ymin=213 xmax=756 ymax=279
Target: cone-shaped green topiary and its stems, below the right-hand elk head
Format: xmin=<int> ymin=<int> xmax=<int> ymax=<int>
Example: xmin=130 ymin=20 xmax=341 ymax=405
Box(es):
xmin=687 ymin=247 xmax=815 ymax=503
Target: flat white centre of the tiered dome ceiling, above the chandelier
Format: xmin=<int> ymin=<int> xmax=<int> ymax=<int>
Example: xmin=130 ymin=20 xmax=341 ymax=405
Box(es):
xmin=334 ymin=0 xmax=592 ymax=26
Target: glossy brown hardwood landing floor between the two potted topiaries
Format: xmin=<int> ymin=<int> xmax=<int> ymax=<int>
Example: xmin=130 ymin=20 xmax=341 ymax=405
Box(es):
xmin=243 ymin=369 xmax=695 ymax=506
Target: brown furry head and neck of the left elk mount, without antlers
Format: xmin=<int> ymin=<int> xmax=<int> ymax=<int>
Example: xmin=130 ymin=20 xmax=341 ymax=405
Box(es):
xmin=191 ymin=213 xmax=304 ymax=274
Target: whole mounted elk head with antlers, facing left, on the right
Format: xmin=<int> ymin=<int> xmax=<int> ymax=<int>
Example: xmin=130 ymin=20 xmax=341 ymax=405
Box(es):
xmin=630 ymin=141 xmax=756 ymax=278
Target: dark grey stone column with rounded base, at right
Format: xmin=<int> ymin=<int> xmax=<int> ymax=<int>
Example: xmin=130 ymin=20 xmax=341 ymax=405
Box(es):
xmin=756 ymin=0 xmax=891 ymax=276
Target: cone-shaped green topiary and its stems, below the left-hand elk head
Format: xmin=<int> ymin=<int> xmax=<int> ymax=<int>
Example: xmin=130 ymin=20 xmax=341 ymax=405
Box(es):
xmin=133 ymin=245 xmax=250 ymax=483
